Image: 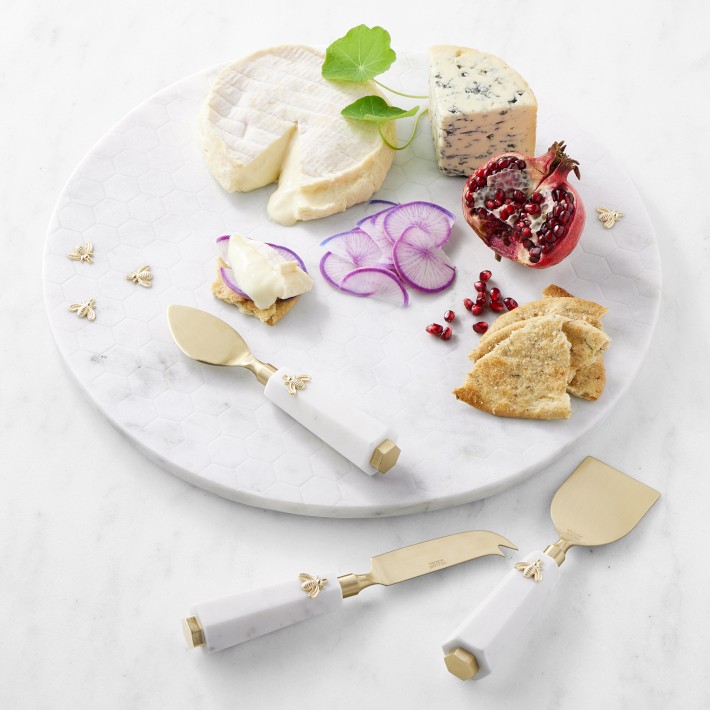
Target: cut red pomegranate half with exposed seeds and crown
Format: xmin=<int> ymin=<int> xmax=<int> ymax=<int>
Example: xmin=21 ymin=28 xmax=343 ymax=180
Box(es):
xmin=462 ymin=141 xmax=585 ymax=269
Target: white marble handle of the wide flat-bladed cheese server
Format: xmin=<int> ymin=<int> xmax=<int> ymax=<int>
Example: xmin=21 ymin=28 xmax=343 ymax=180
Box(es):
xmin=443 ymin=551 xmax=560 ymax=680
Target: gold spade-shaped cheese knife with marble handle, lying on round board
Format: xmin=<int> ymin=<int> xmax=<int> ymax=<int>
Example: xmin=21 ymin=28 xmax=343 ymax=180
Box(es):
xmin=168 ymin=305 xmax=400 ymax=476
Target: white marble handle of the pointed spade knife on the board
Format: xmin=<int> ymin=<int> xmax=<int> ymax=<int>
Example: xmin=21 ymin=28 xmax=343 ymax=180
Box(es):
xmin=264 ymin=368 xmax=399 ymax=476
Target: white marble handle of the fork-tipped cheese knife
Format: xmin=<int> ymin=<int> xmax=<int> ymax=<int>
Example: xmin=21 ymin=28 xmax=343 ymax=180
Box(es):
xmin=183 ymin=575 xmax=343 ymax=653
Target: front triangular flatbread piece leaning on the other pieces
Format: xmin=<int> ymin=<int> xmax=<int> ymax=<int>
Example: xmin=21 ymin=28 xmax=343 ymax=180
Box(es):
xmin=454 ymin=311 xmax=571 ymax=419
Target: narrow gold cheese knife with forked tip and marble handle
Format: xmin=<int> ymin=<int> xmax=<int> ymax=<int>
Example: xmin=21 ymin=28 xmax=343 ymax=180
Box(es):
xmin=183 ymin=530 xmax=517 ymax=653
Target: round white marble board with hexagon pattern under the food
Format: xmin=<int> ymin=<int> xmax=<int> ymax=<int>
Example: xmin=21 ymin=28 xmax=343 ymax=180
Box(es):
xmin=44 ymin=55 xmax=661 ymax=517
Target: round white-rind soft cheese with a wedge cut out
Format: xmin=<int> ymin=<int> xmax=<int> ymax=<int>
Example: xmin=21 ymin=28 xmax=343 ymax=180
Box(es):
xmin=199 ymin=45 xmax=396 ymax=225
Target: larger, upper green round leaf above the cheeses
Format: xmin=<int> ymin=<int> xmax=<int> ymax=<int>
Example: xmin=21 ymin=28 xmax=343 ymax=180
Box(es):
xmin=321 ymin=25 xmax=397 ymax=81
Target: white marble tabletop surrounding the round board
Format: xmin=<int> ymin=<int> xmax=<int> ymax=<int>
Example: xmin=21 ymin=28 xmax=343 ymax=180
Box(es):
xmin=0 ymin=0 xmax=710 ymax=709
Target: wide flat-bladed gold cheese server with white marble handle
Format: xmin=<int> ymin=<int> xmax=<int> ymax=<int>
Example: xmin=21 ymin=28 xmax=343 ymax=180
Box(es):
xmin=443 ymin=456 xmax=660 ymax=680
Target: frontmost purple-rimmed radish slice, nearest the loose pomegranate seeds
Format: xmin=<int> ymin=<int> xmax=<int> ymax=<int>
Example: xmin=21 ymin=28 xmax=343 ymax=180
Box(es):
xmin=392 ymin=227 xmax=456 ymax=293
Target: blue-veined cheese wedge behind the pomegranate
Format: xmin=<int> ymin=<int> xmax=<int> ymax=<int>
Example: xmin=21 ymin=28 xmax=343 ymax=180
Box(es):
xmin=429 ymin=46 xmax=537 ymax=175
